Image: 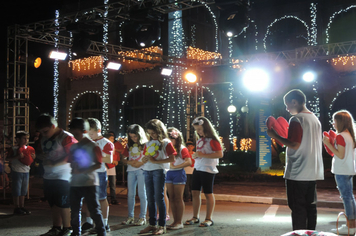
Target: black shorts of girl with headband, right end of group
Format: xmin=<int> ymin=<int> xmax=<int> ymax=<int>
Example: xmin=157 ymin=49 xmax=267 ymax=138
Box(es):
xmin=192 ymin=169 xmax=215 ymax=194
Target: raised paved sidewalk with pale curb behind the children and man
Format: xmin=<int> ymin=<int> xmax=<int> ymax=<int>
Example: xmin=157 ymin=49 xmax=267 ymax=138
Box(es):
xmin=0 ymin=176 xmax=343 ymax=208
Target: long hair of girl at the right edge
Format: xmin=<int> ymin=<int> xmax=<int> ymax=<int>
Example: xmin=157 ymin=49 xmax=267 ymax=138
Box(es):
xmin=333 ymin=110 xmax=356 ymax=147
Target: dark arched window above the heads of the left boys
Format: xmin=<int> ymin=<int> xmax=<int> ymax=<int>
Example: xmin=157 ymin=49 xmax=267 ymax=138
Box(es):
xmin=73 ymin=93 xmax=103 ymax=121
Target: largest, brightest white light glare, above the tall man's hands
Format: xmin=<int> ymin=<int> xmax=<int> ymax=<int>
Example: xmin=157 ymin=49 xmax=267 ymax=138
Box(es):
xmin=243 ymin=69 xmax=269 ymax=91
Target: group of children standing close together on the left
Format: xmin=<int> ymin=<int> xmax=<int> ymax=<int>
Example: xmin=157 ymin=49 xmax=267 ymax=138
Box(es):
xmin=1 ymin=114 xmax=223 ymax=236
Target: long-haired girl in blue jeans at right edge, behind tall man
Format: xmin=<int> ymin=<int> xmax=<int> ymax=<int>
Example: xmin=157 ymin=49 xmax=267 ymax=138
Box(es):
xmin=323 ymin=110 xmax=356 ymax=235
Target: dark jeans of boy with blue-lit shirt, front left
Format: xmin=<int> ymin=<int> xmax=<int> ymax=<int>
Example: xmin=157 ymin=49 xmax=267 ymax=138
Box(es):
xmin=70 ymin=186 xmax=106 ymax=235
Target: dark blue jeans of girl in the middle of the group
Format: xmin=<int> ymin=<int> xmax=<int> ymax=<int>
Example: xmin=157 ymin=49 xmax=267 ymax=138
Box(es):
xmin=144 ymin=169 xmax=166 ymax=226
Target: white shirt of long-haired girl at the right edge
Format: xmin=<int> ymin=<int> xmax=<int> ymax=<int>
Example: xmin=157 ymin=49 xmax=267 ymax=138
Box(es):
xmin=331 ymin=132 xmax=356 ymax=175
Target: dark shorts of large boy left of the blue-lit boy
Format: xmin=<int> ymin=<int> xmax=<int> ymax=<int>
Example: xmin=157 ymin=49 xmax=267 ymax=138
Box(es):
xmin=43 ymin=179 xmax=70 ymax=208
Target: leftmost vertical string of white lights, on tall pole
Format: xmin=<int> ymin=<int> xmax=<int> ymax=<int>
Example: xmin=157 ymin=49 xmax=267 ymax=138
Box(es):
xmin=53 ymin=10 xmax=59 ymax=120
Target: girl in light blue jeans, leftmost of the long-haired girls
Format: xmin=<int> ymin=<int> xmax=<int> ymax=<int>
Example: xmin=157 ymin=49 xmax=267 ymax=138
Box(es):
xmin=122 ymin=124 xmax=147 ymax=225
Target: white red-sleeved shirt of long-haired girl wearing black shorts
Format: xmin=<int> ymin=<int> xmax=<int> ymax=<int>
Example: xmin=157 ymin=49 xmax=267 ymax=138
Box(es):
xmin=194 ymin=138 xmax=222 ymax=174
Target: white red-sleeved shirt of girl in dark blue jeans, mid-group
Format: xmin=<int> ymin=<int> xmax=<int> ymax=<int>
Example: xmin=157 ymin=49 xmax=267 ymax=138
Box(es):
xmin=142 ymin=139 xmax=177 ymax=172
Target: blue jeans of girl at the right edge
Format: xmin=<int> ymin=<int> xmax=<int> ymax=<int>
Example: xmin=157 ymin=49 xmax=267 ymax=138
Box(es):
xmin=335 ymin=175 xmax=356 ymax=220
